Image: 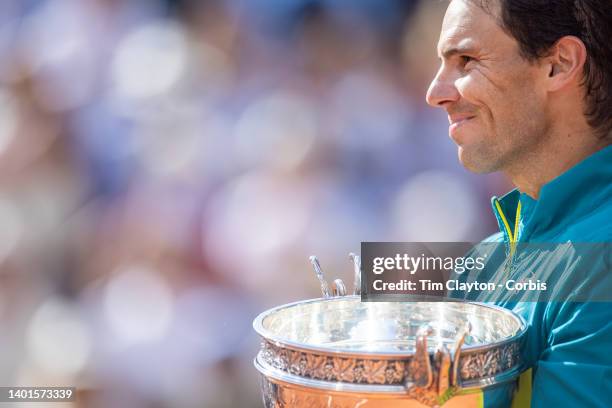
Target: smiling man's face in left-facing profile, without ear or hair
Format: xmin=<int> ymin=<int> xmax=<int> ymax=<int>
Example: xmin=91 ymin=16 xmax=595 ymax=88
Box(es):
xmin=427 ymin=0 xmax=548 ymax=173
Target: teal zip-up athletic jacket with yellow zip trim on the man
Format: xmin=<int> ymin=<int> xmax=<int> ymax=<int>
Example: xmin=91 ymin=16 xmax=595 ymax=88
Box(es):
xmin=466 ymin=146 xmax=612 ymax=408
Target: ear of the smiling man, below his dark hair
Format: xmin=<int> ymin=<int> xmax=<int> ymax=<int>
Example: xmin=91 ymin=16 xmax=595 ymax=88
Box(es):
xmin=546 ymin=35 xmax=587 ymax=91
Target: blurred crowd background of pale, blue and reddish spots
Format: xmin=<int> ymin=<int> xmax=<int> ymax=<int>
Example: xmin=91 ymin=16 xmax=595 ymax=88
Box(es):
xmin=0 ymin=0 xmax=508 ymax=408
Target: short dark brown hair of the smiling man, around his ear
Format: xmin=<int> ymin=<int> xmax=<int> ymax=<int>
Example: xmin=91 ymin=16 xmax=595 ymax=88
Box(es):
xmin=472 ymin=0 xmax=612 ymax=138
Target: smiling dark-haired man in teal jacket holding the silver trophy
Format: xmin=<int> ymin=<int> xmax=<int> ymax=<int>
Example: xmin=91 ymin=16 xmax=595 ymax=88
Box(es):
xmin=427 ymin=0 xmax=612 ymax=407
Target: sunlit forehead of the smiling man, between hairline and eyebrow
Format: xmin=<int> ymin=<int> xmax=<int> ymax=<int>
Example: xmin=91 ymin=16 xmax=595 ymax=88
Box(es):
xmin=438 ymin=0 xmax=501 ymax=56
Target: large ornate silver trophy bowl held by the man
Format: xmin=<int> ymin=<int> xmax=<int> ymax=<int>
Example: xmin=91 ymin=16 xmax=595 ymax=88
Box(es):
xmin=253 ymin=296 xmax=526 ymax=408
